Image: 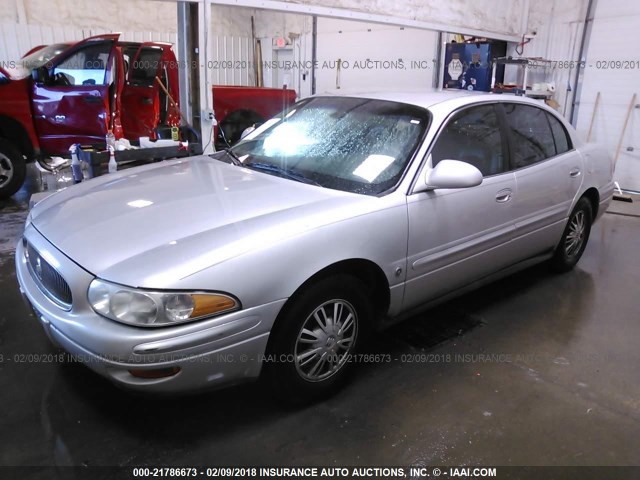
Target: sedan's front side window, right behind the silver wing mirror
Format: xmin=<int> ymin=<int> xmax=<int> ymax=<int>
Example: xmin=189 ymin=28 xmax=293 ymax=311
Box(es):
xmin=431 ymin=105 xmax=505 ymax=177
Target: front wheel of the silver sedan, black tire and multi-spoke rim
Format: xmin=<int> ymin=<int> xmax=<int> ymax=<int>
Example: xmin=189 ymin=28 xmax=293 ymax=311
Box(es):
xmin=264 ymin=274 xmax=371 ymax=403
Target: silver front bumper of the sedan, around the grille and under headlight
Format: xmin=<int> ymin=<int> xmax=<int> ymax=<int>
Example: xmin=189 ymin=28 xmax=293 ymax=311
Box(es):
xmin=16 ymin=226 xmax=285 ymax=393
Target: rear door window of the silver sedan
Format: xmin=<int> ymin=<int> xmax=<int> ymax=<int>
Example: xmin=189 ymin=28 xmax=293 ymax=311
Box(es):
xmin=504 ymin=103 xmax=556 ymax=168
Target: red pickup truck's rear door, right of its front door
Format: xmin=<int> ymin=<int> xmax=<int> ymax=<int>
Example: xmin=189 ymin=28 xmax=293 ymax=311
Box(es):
xmin=122 ymin=42 xmax=180 ymax=140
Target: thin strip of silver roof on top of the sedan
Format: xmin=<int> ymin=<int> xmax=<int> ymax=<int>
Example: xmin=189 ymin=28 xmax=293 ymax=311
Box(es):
xmin=316 ymin=89 xmax=540 ymax=109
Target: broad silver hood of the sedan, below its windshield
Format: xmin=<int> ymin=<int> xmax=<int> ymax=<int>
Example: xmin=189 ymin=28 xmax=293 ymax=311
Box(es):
xmin=31 ymin=156 xmax=376 ymax=288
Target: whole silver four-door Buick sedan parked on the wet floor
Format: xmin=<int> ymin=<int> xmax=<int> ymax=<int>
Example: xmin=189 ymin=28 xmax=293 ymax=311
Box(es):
xmin=16 ymin=92 xmax=613 ymax=400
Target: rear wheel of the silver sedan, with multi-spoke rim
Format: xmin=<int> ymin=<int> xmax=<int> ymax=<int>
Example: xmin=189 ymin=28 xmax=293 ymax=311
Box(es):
xmin=551 ymin=197 xmax=593 ymax=273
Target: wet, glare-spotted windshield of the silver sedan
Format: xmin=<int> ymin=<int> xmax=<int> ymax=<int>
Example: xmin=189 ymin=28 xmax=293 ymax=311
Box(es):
xmin=231 ymin=97 xmax=429 ymax=195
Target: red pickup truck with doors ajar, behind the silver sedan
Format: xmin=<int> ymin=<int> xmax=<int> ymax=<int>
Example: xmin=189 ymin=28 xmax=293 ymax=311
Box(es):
xmin=0 ymin=34 xmax=295 ymax=198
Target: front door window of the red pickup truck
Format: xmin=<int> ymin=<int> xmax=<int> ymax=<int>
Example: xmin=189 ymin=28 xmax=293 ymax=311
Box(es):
xmin=54 ymin=42 xmax=112 ymax=85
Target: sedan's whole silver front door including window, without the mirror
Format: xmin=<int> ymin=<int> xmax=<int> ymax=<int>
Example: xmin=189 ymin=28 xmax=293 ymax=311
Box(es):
xmin=404 ymin=104 xmax=518 ymax=309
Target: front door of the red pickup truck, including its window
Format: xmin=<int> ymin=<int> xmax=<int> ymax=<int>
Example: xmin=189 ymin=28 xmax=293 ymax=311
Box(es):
xmin=31 ymin=34 xmax=122 ymax=155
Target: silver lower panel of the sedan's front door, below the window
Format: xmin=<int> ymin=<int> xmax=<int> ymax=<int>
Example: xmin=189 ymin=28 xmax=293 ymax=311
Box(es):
xmin=404 ymin=173 xmax=517 ymax=309
